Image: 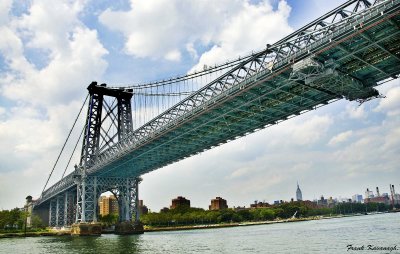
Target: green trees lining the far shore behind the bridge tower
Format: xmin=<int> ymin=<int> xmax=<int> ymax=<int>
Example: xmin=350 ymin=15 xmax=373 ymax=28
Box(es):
xmin=0 ymin=201 xmax=393 ymax=237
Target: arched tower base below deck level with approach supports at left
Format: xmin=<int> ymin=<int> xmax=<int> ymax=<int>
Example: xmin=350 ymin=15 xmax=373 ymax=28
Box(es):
xmin=34 ymin=176 xmax=141 ymax=227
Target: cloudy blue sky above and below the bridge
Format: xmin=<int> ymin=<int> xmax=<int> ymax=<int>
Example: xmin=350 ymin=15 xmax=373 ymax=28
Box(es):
xmin=0 ymin=0 xmax=400 ymax=211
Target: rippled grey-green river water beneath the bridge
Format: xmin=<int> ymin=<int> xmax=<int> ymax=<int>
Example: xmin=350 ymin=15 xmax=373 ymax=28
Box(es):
xmin=0 ymin=213 xmax=400 ymax=254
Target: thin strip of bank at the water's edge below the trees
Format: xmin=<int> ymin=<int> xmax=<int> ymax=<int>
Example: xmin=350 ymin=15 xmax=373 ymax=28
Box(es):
xmin=0 ymin=213 xmax=396 ymax=239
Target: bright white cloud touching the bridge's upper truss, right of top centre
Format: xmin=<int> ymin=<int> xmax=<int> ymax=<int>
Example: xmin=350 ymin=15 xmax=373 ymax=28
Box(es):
xmin=191 ymin=1 xmax=292 ymax=72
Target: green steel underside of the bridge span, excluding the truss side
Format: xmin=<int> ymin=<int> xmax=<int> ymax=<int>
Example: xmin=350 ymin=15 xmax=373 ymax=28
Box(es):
xmin=93 ymin=11 xmax=400 ymax=179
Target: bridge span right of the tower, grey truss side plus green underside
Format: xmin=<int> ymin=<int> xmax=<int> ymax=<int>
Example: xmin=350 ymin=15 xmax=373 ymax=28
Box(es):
xmin=89 ymin=0 xmax=400 ymax=178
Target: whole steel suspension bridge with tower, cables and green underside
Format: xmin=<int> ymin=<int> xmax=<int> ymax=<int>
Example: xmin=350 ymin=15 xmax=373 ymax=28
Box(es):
xmin=30 ymin=0 xmax=400 ymax=234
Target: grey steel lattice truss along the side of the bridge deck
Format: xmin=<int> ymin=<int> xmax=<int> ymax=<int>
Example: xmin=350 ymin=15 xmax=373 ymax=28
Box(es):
xmin=89 ymin=1 xmax=399 ymax=173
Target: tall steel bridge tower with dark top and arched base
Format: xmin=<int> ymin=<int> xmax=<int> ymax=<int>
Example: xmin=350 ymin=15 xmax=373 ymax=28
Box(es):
xmin=75 ymin=82 xmax=135 ymax=222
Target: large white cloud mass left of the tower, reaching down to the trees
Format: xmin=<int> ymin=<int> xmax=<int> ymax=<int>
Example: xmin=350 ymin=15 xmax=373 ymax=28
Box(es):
xmin=0 ymin=0 xmax=107 ymax=208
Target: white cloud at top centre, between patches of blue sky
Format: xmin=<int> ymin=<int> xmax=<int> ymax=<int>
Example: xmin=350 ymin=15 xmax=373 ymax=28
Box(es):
xmin=100 ymin=0 xmax=231 ymax=60
